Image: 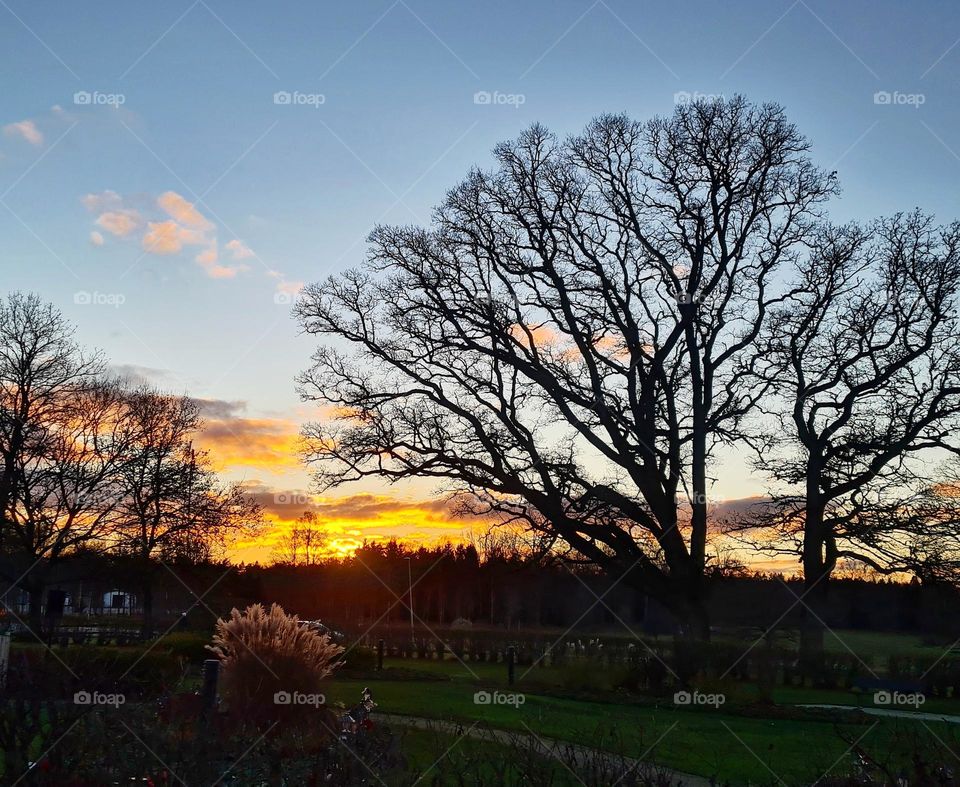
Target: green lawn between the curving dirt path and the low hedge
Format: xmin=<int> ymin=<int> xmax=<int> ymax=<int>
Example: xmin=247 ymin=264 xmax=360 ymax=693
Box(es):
xmin=328 ymin=660 xmax=960 ymax=784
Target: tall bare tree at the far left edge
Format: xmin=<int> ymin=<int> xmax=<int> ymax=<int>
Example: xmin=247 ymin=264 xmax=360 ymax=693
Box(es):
xmin=0 ymin=293 xmax=131 ymax=626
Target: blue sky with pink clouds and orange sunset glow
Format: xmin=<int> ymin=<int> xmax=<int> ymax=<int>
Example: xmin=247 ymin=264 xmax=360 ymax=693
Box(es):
xmin=0 ymin=0 xmax=960 ymax=559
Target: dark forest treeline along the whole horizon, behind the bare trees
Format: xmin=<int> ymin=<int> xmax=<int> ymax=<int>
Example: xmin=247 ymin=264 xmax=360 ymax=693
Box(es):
xmin=13 ymin=542 xmax=960 ymax=642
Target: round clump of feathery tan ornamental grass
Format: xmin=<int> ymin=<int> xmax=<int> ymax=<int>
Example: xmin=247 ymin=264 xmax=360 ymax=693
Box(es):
xmin=208 ymin=604 xmax=343 ymax=726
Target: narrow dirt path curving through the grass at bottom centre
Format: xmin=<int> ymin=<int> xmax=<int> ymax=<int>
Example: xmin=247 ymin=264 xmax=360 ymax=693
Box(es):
xmin=377 ymin=713 xmax=711 ymax=787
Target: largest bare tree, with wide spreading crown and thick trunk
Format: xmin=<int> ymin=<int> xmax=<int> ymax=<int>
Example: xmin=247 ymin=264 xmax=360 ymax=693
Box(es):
xmin=296 ymin=98 xmax=834 ymax=637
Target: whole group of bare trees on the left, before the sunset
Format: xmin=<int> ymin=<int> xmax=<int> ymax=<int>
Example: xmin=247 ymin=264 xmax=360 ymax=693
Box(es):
xmin=0 ymin=293 xmax=260 ymax=631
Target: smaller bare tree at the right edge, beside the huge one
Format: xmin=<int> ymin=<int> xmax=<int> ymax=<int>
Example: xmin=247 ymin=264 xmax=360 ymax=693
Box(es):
xmin=755 ymin=212 xmax=960 ymax=658
